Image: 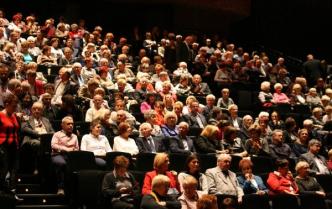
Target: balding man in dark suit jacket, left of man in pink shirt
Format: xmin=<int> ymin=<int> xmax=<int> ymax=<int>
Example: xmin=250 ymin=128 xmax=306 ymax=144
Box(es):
xmin=22 ymin=102 xmax=54 ymax=174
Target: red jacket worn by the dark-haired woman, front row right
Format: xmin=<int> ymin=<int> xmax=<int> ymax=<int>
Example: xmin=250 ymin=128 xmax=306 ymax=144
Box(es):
xmin=267 ymin=171 xmax=299 ymax=195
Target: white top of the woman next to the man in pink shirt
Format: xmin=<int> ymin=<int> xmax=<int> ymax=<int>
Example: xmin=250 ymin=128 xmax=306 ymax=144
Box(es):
xmin=81 ymin=134 xmax=112 ymax=156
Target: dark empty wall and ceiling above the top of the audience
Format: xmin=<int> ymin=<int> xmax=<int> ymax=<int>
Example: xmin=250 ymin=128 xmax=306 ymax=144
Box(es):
xmin=0 ymin=0 xmax=332 ymax=60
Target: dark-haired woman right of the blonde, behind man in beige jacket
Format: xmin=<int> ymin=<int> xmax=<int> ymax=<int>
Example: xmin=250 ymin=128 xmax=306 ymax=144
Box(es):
xmin=222 ymin=126 xmax=248 ymax=157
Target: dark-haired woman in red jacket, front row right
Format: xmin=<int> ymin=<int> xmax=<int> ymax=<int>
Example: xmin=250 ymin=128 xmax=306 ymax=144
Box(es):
xmin=267 ymin=159 xmax=299 ymax=195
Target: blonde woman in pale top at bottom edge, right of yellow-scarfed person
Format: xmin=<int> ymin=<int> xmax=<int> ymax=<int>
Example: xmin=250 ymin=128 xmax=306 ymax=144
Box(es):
xmin=178 ymin=175 xmax=203 ymax=209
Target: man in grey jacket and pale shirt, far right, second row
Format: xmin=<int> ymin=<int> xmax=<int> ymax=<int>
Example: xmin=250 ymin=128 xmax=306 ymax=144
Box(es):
xmin=299 ymin=139 xmax=331 ymax=174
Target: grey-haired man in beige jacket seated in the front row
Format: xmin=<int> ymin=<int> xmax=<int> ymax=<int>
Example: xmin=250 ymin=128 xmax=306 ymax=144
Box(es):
xmin=205 ymin=154 xmax=244 ymax=203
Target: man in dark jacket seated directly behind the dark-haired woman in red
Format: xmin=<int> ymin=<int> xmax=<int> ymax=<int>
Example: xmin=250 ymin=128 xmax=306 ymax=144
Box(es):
xmin=269 ymin=129 xmax=296 ymax=159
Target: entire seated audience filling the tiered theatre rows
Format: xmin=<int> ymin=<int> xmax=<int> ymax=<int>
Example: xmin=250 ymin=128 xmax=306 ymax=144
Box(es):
xmin=0 ymin=7 xmax=332 ymax=208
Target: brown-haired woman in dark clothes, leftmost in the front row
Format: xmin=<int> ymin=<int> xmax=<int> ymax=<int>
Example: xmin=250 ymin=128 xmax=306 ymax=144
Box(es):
xmin=102 ymin=155 xmax=139 ymax=209
